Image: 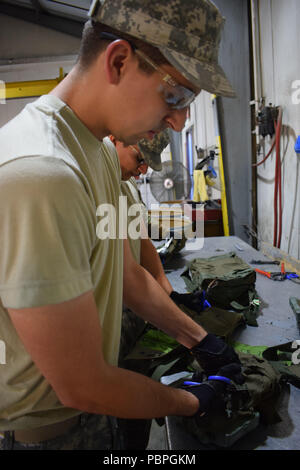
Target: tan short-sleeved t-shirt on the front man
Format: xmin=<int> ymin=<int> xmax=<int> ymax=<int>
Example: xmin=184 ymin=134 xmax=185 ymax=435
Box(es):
xmin=0 ymin=95 xmax=123 ymax=430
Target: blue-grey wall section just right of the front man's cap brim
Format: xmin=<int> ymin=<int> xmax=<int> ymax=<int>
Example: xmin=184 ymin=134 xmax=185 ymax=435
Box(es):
xmin=215 ymin=0 xmax=252 ymax=243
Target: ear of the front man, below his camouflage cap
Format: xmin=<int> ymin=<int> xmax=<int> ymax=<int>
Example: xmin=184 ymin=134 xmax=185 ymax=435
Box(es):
xmin=104 ymin=39 xmax=133 ymax=85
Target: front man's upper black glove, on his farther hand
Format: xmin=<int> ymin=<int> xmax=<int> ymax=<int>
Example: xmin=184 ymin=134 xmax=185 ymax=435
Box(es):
xmin=191 ymin=333 xmax=243 ymax=383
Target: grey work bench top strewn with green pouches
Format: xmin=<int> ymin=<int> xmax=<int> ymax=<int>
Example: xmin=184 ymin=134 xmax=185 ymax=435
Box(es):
xmin=161 ymin=236 xmax=300 ymax=450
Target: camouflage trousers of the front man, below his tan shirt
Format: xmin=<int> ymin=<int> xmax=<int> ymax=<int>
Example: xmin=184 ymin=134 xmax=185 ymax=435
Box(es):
xmin=0 ymin=413 xmax=121 ymax=450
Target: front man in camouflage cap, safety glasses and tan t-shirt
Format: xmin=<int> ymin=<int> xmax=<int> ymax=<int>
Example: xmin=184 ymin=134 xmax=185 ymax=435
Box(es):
xmin=0 ymin=0 xmax=241 ymax=450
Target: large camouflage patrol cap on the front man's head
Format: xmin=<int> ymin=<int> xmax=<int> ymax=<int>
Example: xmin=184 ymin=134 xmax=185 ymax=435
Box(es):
xmin=89 ymin=0 xmax=235 ymax=97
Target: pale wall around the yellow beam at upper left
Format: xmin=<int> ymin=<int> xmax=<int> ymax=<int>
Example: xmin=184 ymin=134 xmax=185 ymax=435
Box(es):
xmin=0 ymin=14 xmax=80 ymax=126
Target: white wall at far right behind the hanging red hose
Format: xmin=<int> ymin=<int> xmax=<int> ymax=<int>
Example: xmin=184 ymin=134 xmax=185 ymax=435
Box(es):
xmin=257 ymin=0 xmax=300 ymax=259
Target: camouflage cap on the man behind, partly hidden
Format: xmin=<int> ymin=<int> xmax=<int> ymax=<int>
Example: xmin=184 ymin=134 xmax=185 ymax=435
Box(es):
xmin=138 ymin=129 xmax=170 ymax=171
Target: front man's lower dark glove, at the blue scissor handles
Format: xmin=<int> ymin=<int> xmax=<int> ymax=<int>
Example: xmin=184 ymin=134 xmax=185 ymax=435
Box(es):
xmin=181 ymin=363 xmax=240 ymax=416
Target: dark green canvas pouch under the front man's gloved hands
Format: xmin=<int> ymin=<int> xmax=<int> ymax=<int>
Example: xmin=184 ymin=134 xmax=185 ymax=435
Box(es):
xmin=172 ymin=352 xmax=282 ymax=447
